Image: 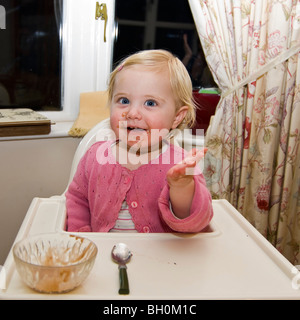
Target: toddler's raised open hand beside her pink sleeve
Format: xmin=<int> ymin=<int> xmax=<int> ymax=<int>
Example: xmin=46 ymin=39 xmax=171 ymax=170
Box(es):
xmin=167 ymin=148 xmax=207 ymax=188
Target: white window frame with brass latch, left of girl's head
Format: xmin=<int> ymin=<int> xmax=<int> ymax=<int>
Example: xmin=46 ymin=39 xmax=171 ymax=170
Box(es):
xmin=40 ymin=0 xmax=115 ymax=121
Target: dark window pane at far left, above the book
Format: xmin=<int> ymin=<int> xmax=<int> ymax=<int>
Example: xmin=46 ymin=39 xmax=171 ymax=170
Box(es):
xmin=0 ymin=0 xmax=62 ymax=111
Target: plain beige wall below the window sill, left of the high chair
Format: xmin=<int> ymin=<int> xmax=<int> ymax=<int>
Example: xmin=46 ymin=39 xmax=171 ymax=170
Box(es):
xmin=0 ymin=137 xmax=80 ymax=265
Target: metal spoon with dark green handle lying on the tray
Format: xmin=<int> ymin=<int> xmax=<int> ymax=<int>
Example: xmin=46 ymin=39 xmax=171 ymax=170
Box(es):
xmin=111 ymin=243 xmax=132 ymax=294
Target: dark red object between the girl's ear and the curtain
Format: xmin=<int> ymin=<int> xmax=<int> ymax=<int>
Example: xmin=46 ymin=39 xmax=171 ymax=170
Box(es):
xmin=192 ymin=91 xmax=220 ymax=134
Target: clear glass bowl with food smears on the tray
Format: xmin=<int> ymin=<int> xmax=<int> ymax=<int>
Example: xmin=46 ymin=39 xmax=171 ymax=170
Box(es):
xmin=13 ymin=233 xmax=98 ymax=293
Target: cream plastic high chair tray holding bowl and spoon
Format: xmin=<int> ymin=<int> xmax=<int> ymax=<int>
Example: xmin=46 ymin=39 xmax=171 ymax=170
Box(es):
xmin=0 ymin=196 xmax=300 ymax=300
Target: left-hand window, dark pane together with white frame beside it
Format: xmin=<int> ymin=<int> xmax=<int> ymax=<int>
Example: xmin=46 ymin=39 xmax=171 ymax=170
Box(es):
xmin=0 ymin=0 xmax=115 ymax=121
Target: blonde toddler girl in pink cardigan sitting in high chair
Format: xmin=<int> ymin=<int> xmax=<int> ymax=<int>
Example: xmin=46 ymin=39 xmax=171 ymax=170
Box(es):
xmin=66 ymin=50 xmax=213 ymax=232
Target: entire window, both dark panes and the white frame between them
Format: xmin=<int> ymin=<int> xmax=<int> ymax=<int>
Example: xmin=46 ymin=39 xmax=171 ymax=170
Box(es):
xmin=0 ymin=0 xmax=216 ymax=125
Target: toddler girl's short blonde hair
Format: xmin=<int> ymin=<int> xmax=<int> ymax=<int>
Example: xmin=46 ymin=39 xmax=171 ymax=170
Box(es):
xmin=108 ymin=50 xmax=196 ymax=129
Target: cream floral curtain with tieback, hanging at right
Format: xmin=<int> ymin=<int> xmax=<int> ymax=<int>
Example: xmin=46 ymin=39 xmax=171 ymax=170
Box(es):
xmin=189 ymin=0 xmax=300 ymax=264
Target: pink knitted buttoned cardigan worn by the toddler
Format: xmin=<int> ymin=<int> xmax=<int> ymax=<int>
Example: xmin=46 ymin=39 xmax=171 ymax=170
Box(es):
xmin=66 ymin=141 xmax=213 ymax=232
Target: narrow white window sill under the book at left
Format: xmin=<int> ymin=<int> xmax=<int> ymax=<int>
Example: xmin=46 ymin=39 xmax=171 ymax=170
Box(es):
xmin=0 ymin=121 xmax=74 ymax=141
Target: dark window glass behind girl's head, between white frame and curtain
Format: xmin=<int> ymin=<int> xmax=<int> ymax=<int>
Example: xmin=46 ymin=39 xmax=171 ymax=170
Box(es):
xmin=113 ymin=0 xmax=215 ymax=89
